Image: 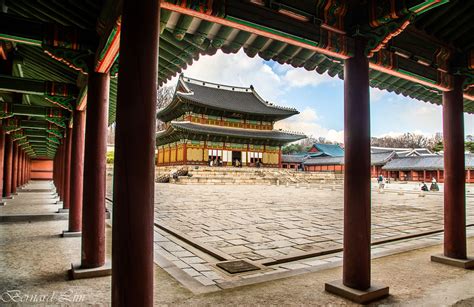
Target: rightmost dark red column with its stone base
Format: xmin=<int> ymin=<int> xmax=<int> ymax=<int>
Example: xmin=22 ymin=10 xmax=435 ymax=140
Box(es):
xmin=431 ymin=75 xmax=474 ymax=268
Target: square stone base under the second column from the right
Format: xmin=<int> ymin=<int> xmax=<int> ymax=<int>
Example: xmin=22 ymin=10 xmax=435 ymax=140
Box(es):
xmin=324 ymin=280 xmax=389 ymax=304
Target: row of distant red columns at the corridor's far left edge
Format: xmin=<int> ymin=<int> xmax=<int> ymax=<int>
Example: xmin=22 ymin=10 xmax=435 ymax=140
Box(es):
xmin=0 ymin=128 xmax=31 ymax=198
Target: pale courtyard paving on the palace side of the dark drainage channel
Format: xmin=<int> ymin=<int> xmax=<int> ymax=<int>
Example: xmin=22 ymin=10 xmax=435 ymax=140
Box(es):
xmin=155 ymin=184 xmax=474 ymax=263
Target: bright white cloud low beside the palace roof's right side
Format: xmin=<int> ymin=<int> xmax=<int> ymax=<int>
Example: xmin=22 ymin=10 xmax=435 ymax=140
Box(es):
xmin=275 ymin=107 xmax=344 ymax=143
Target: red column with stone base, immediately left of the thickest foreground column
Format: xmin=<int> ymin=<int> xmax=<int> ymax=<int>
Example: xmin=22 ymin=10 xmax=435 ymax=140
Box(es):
xmin=73 ymin=69 xmax=111 ymax=278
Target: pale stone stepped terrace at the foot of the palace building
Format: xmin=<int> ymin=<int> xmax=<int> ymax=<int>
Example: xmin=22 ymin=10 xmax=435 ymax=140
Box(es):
xmin=157 ymin=166 xmax=343 ymax=186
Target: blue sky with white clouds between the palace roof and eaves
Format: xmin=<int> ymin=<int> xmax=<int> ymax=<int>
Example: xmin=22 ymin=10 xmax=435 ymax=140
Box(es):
xmin=168 ymin=50 xmax=474 ymax=142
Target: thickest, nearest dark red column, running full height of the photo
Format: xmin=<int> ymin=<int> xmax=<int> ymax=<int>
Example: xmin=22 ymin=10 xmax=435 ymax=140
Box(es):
xmin=112 ymin=0 xmax=160 ymax=306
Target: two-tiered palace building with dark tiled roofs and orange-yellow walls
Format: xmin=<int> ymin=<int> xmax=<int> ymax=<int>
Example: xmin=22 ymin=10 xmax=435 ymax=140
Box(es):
xmin=156 ymin=75 xmax=306 ymax=167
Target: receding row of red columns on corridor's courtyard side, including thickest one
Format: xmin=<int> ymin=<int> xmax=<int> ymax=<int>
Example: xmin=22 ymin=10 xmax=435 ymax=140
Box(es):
xmin=49 ymin=1 xmax=159 ymax=306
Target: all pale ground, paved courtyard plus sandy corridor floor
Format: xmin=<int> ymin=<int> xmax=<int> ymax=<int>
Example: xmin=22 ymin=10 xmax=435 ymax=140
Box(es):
xmin=0 ymin=180 xmax=474 ymax=306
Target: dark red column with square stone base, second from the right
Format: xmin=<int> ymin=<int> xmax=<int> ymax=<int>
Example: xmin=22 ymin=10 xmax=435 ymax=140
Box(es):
xmin=326 ymin=38 xmax=388 ymax=303
